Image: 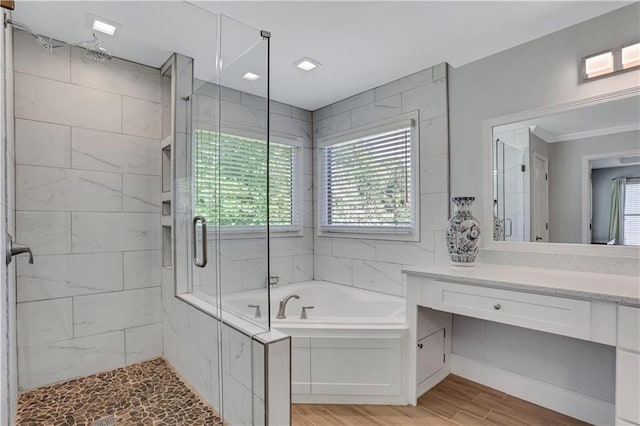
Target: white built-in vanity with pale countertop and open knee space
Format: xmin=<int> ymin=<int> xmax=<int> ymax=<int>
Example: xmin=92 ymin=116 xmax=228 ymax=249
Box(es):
xmin=403 ymin=264 xmax=640 ymax=425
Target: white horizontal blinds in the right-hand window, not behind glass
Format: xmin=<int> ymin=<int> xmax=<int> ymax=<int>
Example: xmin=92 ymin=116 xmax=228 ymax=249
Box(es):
xmin=323 ymin=123 xmax=413 ymax=228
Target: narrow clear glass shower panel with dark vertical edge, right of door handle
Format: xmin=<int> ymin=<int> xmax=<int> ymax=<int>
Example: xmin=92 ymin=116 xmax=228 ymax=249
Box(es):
xmin=217 ymin=16 xmax=270 ymax=330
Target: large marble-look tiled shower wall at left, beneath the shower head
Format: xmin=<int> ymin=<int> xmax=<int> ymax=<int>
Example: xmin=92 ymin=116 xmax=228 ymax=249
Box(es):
xmin=15 ymin=32 xmax=162 ymax=389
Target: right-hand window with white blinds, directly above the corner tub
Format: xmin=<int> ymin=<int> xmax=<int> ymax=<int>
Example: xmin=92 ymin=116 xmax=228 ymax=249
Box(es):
xmin=319 ymin=116 xmax=417 ymax=239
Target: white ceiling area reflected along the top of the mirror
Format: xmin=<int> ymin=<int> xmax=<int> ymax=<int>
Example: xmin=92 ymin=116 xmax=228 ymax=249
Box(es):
xmin=494 ymin=96 xmax=640 ymax=143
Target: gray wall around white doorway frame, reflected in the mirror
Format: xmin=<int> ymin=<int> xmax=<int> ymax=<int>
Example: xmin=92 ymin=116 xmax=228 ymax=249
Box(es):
xmin=549 ymin=131 xmax=640 ymax=243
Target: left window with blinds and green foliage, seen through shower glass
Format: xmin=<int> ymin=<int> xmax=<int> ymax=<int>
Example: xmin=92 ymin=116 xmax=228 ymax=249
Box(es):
xmin=195 ymin=129 xmax=300 ymax=231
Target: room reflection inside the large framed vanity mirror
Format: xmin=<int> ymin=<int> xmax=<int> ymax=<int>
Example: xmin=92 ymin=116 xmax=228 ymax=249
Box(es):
xmin=492 ymin=96 xmax=640 ymax=246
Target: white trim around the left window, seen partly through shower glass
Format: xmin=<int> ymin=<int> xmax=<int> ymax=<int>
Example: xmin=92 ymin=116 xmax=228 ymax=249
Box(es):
xmin=192 ymin=122 xmax=304 ymax=240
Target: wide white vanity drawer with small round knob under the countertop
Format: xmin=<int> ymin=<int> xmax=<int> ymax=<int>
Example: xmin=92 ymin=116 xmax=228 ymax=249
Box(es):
xmin=425 ymin=281 xmax=591 ymax=339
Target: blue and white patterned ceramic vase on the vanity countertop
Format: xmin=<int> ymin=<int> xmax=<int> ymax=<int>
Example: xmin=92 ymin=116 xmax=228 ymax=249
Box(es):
xmin=447 ymin=197 xmax=480 ymax=266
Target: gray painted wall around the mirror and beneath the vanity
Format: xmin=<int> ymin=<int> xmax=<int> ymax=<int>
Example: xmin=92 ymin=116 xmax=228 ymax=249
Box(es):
xmin=449 ymin=3 xmax=640 ymax=408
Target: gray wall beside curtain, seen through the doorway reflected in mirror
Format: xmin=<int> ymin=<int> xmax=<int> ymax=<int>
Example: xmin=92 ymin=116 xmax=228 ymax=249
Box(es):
xmin=591 ymin=163 xmax=640 ymax=244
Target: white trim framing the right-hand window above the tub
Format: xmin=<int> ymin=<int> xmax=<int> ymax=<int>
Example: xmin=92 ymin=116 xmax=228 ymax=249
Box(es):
xmin=315 ymin=111 xmax=420 ymax=241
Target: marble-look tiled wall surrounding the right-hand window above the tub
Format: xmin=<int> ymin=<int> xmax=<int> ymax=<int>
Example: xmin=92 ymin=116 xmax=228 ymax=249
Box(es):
xmin=313 ymin=64 xmax=449 ymax=296
